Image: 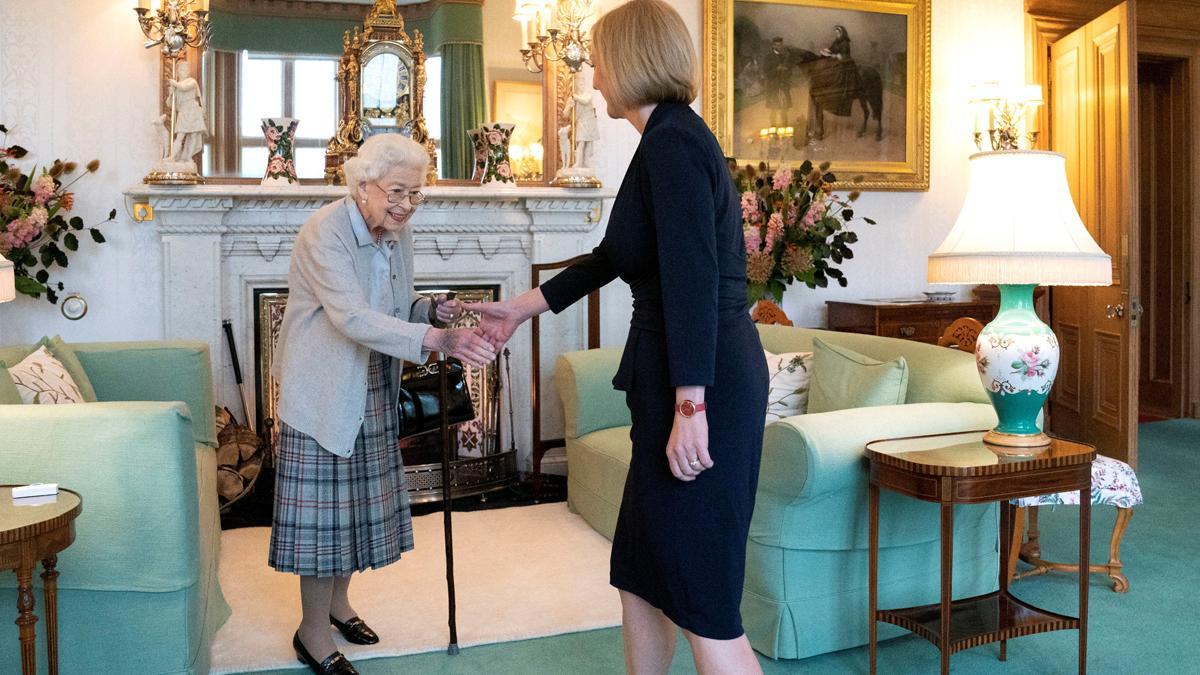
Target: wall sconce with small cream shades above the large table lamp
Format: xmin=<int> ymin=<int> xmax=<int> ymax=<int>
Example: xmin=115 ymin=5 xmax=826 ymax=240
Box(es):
xmin=970 ymin=82 xmax=1043 ymax=150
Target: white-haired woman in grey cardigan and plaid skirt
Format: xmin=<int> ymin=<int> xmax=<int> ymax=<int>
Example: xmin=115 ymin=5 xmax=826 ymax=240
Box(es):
xmin=269 ymin=135 xmax=496 ymax=675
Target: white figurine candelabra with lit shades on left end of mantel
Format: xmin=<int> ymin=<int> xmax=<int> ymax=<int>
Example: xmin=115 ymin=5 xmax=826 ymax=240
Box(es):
xmin=133 ymin=0 xmax=212 ymax=184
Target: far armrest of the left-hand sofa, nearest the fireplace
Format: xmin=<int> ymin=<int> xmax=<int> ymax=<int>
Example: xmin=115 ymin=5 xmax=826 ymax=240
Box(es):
xmin=71 ymin=340 xmax=217 ymax=448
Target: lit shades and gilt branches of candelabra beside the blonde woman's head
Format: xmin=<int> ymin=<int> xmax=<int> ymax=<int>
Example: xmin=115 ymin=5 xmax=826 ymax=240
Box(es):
xmin=512 ymin=0 xmax=593 ymax=73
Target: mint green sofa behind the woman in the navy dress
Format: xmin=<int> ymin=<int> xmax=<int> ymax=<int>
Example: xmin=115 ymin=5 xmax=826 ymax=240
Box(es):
xmin=554 ymin=325 xmax=998 ymax=658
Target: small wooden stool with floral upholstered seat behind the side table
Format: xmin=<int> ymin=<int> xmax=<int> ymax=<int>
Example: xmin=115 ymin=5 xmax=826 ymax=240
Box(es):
xmin=1008 ymin=455 xmax=1141 ymax=593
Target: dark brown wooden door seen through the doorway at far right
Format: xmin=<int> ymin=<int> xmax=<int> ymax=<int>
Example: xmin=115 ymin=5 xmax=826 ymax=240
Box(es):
xmin=1138 ymin=58 xmax=1193 ymax=418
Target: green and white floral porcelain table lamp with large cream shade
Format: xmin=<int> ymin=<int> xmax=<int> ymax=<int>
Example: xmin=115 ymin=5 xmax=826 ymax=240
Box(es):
xmin=929 ymin=150 xmax=1112 ymax=450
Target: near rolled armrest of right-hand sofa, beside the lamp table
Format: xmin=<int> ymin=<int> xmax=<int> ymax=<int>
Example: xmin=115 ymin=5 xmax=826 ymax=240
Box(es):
xmin=758 ymin=404 xmax=996 ymax=503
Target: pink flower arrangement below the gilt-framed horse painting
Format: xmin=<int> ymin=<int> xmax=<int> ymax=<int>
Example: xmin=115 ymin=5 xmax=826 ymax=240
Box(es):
xmin=731 ymin=161 xmax=875 ymax=304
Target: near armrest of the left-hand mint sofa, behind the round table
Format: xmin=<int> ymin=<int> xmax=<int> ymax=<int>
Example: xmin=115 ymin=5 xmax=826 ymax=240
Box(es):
xmin=0 ymin=402 xmax=200 ymax=591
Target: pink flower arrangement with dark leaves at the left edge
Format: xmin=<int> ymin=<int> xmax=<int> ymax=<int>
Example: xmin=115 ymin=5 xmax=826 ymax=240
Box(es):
xmin=0 ymin=125 xmax=116 ymax=304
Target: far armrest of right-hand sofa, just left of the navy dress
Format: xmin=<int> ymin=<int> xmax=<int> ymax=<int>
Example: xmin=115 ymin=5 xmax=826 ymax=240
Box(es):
xmin=554 ymin=347 xmax=631 ymax=438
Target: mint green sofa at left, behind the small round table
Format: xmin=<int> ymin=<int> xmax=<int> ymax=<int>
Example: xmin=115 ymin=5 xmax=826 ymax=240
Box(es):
xmin=0 ymin=342 xmax=229 ymax=674
